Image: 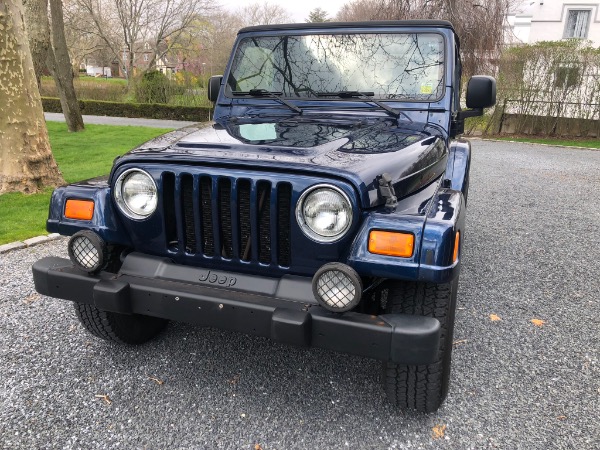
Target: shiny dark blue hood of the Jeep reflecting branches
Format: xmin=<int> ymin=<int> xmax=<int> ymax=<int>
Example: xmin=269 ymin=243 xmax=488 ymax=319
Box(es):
xmin=115 ymin=114 xmax=447 ymax=208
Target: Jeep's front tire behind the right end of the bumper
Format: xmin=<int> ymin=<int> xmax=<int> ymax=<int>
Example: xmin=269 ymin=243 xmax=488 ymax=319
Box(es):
xmin=383 ymin=278 xmax=458 ymax=412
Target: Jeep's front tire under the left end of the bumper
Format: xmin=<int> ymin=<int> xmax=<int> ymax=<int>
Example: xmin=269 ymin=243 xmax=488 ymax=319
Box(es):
xmin=75 ymin=303 xmax=168 ymax=345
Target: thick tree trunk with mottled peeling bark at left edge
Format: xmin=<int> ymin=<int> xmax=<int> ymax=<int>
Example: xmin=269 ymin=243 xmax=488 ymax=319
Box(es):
xmin=0 ymin=0 xmax=64 ymax=194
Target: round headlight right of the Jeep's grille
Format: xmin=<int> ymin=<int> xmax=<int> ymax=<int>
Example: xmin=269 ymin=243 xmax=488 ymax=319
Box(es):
xmin=296 ymin=185 xmax=352 ymax=242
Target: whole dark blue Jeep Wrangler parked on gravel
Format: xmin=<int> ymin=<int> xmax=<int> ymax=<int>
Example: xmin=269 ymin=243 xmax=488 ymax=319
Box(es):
xmin=33 ymin=21 xmax=496 ymax=412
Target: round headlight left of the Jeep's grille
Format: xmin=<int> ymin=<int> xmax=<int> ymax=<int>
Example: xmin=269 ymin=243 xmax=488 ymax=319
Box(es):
xmin=115 ymin=169 xmax=158 ymax=219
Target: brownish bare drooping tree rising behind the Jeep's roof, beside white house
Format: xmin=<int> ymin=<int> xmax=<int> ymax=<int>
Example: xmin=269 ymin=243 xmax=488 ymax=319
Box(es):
xmin=338 ymin=0 xmax=517 ymax=76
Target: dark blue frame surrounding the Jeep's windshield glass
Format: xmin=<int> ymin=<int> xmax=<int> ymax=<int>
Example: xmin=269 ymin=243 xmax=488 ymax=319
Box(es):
xmin=223 ymin=26 xmax=451 ymax=104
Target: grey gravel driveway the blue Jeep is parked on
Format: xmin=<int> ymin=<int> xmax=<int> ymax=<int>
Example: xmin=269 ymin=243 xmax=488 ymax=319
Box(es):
xmin=0 ymin=141 xmax=600 ymax=450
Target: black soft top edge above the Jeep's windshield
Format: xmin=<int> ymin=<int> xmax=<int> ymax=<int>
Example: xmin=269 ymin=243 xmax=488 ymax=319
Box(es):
xmin=238 ymin=20 xmax=454 ymax=34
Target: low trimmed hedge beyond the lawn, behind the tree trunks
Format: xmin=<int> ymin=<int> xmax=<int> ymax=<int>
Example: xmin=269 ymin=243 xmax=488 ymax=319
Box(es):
xmin=42 ymin=97 xmax=210 ymax=122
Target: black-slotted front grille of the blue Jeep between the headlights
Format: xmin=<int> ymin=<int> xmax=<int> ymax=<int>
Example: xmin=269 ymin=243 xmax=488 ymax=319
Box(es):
xmin=162 ymin=172 xmax=292 ymax=267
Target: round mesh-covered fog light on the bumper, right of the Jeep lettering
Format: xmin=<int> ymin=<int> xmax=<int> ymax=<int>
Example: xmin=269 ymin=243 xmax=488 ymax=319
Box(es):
xmin=312 ymin=263 xmax=362 ymax=312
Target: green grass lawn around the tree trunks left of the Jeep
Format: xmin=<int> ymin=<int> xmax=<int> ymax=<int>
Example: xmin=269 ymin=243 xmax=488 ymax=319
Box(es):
xmin=0 ymin=122 xmax=169 ymax=245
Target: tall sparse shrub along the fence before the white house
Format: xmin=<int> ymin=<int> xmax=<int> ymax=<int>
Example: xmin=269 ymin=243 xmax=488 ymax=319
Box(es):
xmin=496 ymin=39 xmax=600 ymax=136
